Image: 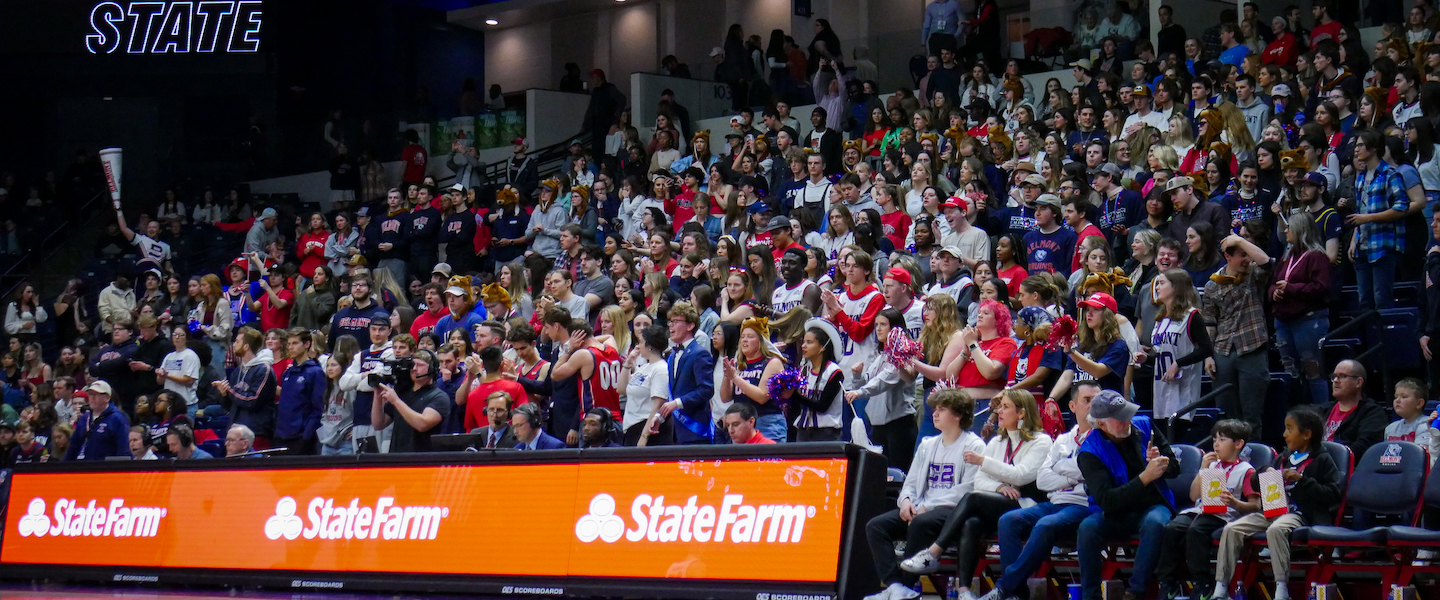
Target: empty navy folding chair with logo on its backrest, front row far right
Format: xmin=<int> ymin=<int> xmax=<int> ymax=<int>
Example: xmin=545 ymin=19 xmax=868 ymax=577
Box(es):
xmin=1293 ymin=442 xmax=1430 ymax=590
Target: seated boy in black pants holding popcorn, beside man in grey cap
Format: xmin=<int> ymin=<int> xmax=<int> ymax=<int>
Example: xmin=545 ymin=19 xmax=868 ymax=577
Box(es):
xmin=1155 ymin=419 xmax=1260 ymax=599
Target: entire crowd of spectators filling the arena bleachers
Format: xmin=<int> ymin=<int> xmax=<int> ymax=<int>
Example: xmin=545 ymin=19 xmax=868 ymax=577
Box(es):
xmin=14 ymin=0 xmax=1440 ymax=592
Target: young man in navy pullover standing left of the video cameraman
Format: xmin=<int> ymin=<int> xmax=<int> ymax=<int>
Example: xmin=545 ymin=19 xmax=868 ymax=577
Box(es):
xmin=275 ymin=328 xmax=328 ymax=455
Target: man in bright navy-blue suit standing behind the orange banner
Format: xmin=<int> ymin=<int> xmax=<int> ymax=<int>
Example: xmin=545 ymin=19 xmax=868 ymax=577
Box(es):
xmin=660 ymin=302 xmax=716 ymax=443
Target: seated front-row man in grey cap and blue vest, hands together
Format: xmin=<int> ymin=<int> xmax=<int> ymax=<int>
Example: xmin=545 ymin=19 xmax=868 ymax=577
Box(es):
xmin=1076 ymin=390 xmax=1179 ymax=600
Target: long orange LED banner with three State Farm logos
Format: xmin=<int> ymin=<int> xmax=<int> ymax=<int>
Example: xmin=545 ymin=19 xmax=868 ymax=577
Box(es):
xmin=0 ymin=458 xmax=850 ymax=583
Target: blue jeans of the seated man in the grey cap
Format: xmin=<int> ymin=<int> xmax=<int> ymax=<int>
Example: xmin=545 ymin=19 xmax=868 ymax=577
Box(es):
xmin=1076 ymin=504 xmax=1175 ymax=600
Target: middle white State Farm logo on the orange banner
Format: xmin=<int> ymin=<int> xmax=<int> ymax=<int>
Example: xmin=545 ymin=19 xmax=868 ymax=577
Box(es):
xmin=265 ymin=496 xmax=449 ymax=540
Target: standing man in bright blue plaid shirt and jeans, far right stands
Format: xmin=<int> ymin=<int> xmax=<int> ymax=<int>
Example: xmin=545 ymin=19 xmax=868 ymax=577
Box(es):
xmin=1347 ymin=129 xmax=1410 ymax=311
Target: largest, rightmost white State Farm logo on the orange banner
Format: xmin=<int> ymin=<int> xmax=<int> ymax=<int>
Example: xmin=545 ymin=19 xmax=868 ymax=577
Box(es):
xmin=575 ymin=494 xmax=815 ymax=544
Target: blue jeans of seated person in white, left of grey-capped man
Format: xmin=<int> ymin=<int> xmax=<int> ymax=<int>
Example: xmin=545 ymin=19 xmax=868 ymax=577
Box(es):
xmin=995 ymin=502 xmax=1090 ymax=599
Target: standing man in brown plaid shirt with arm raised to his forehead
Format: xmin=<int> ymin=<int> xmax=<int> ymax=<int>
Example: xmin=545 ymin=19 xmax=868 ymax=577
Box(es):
xmin=1201 ymin=235 xmax=1273 ymax=432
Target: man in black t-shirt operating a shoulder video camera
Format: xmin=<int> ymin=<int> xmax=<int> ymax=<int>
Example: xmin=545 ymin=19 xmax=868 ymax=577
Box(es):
xmin=370 ymin=350 xmax=449 ymax=453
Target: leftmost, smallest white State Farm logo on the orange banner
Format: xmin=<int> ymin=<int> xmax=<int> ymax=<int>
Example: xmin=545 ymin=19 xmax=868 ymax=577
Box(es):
xmin=16 ymin=498 xmax=168 ymax=538
